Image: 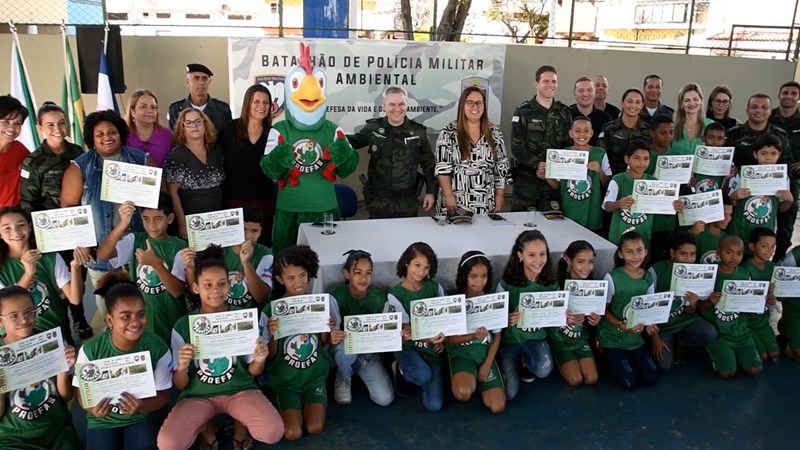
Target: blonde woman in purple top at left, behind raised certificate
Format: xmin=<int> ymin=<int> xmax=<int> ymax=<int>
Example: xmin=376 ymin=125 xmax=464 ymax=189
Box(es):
xmin=125 ymin=89 xmax=172 ymax=167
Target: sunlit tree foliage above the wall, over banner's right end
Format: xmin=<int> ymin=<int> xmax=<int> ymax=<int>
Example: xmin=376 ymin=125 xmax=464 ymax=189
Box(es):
xmin=484 ymin=0 xmax=550 ymax=44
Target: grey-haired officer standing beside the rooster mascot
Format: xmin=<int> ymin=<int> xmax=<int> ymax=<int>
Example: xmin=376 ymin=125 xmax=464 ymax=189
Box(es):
xmin=347 ymin=86 xmax=438 ymax=219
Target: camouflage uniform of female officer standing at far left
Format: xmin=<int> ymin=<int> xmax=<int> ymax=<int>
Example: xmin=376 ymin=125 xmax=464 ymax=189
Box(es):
xmin=19 ymin=142 xmax=83 ymax=213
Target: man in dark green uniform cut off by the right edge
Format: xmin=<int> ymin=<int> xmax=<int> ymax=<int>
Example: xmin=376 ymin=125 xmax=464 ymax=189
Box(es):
xmin=769 ymin=81 xmax=800 ymax=261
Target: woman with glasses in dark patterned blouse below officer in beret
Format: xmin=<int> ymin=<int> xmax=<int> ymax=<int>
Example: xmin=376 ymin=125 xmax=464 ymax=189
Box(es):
xmin=164 ymin=108 xmax=225 ymax=238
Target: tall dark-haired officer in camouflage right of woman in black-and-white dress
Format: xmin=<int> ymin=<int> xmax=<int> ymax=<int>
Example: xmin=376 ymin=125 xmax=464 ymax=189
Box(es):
xmin=511 ymin=66 xmax=572 ymax=211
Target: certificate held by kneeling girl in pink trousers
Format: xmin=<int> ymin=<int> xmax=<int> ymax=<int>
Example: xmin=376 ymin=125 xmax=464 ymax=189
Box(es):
xmin=189 ymin=308 xmax=259 ymax=359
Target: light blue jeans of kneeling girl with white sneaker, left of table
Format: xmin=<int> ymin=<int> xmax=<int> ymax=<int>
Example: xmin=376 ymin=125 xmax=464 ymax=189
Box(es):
xmin=333 ymin=341 xmax=394 ymax=406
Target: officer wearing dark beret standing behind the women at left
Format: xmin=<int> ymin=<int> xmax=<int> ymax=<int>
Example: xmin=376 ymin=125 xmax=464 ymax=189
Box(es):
xmin=167 ymin=64 xmax=233 ymax=131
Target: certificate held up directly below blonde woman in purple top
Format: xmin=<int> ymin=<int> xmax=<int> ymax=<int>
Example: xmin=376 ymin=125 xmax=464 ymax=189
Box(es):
xmin=100 ymin=160 xmax=162 ymax=208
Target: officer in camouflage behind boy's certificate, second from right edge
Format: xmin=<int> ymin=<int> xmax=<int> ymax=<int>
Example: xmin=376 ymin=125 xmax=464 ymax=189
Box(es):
xmin=725 ymin=94 xmax=797 ymax=257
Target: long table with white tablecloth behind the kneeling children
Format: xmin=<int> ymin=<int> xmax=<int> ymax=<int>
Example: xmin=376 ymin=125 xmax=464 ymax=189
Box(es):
xmin=297 ymin=212 xmax=616 ymax=293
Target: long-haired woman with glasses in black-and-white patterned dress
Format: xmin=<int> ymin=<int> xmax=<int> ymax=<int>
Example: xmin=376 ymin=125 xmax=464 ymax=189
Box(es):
xmin=435 ymin=87 xmax=509 ymax=215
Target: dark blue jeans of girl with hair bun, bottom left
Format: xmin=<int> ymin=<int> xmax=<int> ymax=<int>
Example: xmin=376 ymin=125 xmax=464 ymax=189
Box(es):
xmin=86 ymin=417 xmax=163 ymax=450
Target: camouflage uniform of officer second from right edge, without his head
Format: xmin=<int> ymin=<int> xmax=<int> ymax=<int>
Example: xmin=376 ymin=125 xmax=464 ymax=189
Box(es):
xmin=725 ymin=118 xmax=798 ymax=258
